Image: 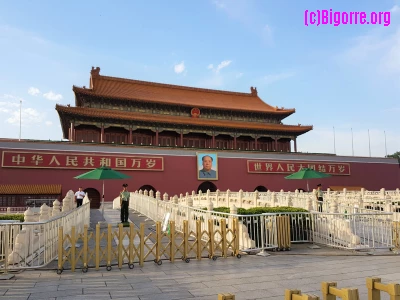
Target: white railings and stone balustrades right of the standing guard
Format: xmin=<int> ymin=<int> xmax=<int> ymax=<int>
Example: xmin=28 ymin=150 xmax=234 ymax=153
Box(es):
xmin=113 ymin=191 xmax=395 ymax=251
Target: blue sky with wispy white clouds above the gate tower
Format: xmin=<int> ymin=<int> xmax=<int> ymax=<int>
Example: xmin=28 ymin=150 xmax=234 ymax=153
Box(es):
xmin=0 ymin=0 xmax=400 ymax=157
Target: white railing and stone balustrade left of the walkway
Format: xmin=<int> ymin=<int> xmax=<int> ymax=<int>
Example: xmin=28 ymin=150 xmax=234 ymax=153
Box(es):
xmin=0 ymin=191 xmax=90 ymax=272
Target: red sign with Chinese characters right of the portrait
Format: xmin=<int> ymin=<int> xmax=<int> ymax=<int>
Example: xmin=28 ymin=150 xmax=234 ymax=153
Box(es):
xmin=247 ymin=160 xmax=350 ymax=176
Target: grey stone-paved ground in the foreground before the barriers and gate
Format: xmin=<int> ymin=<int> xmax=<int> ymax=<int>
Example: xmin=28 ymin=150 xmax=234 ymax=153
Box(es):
xmin=0 ymin=210 xmax=400 ymax=300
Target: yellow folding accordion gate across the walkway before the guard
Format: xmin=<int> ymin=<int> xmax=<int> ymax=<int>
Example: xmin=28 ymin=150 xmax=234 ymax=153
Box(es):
xmin=57 ymin=219 xmax=241 ymax=274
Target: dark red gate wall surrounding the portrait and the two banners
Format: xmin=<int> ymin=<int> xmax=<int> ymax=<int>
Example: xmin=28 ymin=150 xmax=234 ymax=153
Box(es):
xmin=0 ymin=149 xmax=400 ymax=201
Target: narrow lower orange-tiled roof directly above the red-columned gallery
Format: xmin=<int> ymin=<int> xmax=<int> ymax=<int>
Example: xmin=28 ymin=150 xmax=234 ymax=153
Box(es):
xmin=56 ymin=105 xmax=312 ymax=135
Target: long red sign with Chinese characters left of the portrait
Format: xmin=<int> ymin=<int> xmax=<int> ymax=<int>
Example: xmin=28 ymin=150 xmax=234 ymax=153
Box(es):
xmin=1 ymin=151 xmax=164 ymax=171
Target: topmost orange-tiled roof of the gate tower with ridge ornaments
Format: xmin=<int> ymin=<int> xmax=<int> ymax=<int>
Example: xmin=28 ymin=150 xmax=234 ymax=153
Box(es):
xmin=73 ymin=67 xmax=295 ymax=116
